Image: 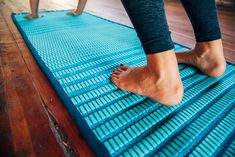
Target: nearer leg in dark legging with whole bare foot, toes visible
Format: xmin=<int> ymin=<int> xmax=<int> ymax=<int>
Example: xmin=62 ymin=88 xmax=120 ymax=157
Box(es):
xmin=112 ymin=0 xmax=183 ymax=105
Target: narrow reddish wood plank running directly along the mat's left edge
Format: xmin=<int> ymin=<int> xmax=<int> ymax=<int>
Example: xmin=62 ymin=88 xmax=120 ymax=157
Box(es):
xmin=1 ymin=1 xmax=94 ymax=156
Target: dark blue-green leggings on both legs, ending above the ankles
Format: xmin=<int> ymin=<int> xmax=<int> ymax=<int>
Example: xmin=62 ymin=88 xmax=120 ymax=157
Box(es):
xmin=122 ymin=0 xmax=221 ymax=54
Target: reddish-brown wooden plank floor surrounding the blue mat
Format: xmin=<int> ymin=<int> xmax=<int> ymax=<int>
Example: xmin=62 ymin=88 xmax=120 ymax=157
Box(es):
xmin=0 ymin=0 xmax=235 ymax=157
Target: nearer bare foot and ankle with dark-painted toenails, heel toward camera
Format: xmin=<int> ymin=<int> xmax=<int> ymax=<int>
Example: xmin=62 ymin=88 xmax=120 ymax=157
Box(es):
xmin=112 ymin=50 xmax=183 ymax=106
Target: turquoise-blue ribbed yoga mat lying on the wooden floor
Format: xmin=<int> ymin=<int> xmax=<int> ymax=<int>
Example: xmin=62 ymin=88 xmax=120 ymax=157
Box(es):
xmin=12 ymin=11 xmax=235 ymax=157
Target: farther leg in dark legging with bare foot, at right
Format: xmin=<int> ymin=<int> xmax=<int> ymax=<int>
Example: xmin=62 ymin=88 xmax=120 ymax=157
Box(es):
xmin=176 ymin=0 xmax=226 ymax=77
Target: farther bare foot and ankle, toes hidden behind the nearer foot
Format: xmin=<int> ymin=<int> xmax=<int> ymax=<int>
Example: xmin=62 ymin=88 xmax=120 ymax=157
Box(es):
xmin=176 ymin=39 xmax=226 ymax=77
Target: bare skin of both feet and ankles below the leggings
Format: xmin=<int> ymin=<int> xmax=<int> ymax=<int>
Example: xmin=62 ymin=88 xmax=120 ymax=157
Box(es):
xmin=112 ymin=39 xmax=226 ymax=106
